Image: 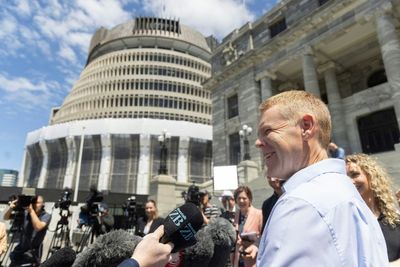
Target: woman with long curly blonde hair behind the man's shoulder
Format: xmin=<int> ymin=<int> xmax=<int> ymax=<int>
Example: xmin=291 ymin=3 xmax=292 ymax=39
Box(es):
xmin=346 ymin=154 xmax=400 ymax=266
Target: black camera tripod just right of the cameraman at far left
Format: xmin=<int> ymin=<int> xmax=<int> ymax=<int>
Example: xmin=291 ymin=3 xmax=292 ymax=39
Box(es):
xmin=46 ymin=208 xmax=71 ymax=259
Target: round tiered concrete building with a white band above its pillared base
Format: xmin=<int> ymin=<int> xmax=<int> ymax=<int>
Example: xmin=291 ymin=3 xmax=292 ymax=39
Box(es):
xmin=19 ymin=18 xmax=212 ymax=194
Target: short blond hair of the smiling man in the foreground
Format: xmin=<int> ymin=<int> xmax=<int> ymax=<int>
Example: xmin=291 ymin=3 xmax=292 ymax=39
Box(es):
xmin=260 ymin=90 xmax=332 ymax=149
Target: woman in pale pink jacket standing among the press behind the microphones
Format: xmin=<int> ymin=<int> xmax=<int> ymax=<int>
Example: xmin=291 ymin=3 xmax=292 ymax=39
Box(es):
xmin=232 ymin=186 xmax=262 ymax=267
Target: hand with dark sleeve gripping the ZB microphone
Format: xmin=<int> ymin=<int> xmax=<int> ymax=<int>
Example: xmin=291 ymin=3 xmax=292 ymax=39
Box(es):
xmin=118 ymin=225 xmax=174 ymax=267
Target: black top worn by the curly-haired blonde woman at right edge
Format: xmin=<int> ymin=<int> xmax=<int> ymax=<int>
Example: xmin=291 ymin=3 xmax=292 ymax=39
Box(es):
xmin=378 ymin=215 xmax=400 ymax=261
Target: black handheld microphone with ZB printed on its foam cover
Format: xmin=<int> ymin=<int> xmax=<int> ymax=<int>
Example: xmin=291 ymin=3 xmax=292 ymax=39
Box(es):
xmin=160 ymin=202 xmax=204 ymax=253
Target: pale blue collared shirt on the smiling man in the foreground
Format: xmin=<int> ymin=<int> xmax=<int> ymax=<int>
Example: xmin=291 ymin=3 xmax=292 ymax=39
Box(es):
xmin=257 ymin=159 xmax=388 ymax=267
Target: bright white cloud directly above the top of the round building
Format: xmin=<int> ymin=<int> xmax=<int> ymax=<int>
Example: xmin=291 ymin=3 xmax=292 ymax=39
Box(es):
xmin=144 ymin=0 xmax=255 ymax=38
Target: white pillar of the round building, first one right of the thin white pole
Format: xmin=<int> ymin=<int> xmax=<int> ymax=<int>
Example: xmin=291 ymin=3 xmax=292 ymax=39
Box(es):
xmin=97 ymin=134 xmax=111 ymax=191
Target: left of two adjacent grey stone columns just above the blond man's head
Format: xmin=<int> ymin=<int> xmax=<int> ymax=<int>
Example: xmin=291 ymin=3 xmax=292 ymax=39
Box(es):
xmin=303 ymin=47 xmax=321 ymax=97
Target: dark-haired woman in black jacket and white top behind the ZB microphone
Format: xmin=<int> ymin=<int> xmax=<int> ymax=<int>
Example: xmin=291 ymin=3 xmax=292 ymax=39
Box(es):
xmin=135 ymin=199 xmax=164 ymax=236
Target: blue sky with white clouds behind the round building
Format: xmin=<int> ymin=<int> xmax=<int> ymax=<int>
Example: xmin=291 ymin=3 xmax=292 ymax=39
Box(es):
xmin=0 ymin=0 xmax=279 ymax=170
